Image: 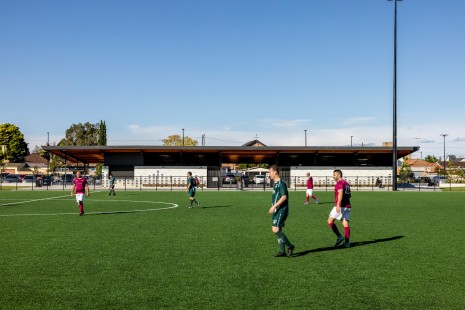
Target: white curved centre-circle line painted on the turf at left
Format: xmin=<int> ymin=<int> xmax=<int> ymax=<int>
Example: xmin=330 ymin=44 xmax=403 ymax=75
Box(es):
xmin=0 ymin=196 xmax=179 ymax=217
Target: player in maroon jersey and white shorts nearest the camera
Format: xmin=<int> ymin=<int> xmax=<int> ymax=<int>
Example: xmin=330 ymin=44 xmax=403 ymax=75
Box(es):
xmin=328 ymin=169 xmax=351 ymax=248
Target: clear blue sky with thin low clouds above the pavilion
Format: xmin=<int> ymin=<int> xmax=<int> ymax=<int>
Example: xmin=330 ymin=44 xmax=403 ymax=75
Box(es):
xmin=0 ymin=0 xmax=465 ymax=157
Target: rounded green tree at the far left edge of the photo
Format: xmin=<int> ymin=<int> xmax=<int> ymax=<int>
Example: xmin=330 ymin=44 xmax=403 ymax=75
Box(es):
xmin=0 ymin=123 xmax=29 ymax=163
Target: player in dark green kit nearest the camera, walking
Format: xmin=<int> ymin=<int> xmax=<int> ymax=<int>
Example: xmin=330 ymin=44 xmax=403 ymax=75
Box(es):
xmin=268 ymin=165 xmax=295 ymax=257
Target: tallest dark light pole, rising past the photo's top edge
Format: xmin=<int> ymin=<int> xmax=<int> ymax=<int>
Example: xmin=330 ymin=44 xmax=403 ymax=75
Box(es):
xmin=388 ymin=0 xmax=402 ymax=191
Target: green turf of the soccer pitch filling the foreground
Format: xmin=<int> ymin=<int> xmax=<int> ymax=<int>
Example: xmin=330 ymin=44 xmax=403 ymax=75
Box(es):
xmin=0 ymin=191 xmax=465 ymax=309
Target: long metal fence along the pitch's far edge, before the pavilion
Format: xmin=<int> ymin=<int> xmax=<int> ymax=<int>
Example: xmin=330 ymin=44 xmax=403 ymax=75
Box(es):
xmin=0 ymin=176 xmax=465 ymax=191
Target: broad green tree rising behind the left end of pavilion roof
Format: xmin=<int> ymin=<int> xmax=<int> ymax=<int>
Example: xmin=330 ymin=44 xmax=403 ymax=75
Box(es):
xmin=58 ymin=122 xmax=99 ymax=146
